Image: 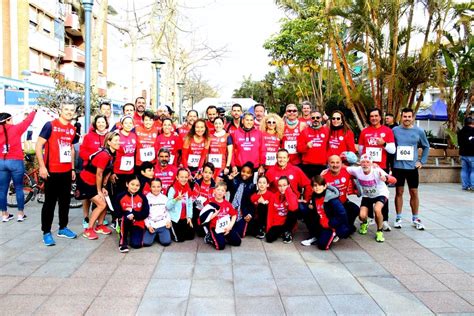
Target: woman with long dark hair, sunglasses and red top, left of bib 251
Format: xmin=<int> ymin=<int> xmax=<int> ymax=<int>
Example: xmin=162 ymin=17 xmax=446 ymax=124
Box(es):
xmin=327 ymin=110 xmax=356 ymax=158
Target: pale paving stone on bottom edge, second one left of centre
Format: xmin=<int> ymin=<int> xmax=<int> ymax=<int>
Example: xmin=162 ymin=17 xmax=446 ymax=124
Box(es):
xmin=134 ymin=297 xmax=188 ymax=316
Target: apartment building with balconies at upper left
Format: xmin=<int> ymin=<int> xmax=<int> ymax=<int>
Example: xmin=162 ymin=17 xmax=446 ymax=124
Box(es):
xmin=0 ymin=0 xmax=107 ymax=105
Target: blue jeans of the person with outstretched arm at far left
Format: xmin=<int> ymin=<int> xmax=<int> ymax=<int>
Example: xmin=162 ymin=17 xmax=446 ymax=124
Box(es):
xmin=0 ymin=160 xmax=25 ymax=211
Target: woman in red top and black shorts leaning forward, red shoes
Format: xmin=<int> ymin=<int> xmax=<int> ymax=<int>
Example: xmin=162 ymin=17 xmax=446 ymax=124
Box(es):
xmin=76 ymin=132 xmax=120 ymax=240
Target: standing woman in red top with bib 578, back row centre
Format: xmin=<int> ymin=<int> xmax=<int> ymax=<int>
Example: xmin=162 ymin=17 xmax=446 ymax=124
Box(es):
xmin=207 ymin=117 xmax=234 ymax=179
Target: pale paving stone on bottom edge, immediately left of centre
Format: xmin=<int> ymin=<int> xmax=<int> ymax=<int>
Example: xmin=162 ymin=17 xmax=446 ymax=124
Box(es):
xmin=186 ymin=297 xmax=236 ymax=315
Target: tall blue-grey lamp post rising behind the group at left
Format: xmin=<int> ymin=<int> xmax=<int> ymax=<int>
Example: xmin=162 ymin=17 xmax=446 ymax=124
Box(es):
xmin=82 ymin=0 xmax=94 ymax=130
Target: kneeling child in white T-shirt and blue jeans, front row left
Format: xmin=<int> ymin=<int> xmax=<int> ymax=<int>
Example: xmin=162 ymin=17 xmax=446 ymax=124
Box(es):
xmin=143 ymin=179 xmax=171 ymax=247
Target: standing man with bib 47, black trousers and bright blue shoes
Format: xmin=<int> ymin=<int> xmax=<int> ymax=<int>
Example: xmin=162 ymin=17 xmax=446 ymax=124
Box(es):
xmin=35 ymin=103 xmax=77 ymax=246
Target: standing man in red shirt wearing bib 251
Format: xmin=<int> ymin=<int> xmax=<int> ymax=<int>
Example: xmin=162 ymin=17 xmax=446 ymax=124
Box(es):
xmin=359 ymin=108 xmax=396 ymax=231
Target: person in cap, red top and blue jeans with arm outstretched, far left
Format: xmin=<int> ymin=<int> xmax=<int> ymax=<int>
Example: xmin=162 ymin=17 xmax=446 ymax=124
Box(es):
xmin=0 ymin=110 xmax=36 ymax=222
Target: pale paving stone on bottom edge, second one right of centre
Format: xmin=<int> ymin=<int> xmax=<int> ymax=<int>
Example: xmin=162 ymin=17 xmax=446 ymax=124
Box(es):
xmin=281 ymin=296 xmax=335 ymax=316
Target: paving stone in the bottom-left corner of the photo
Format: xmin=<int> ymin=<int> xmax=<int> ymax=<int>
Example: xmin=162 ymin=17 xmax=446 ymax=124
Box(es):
xmin=0 ymin=295 xmax=47 ymax=315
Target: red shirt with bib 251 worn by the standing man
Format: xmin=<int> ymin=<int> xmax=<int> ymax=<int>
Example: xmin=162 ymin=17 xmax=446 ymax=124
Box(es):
xmin=359 ymin=125 xmax=395 ymax=169
